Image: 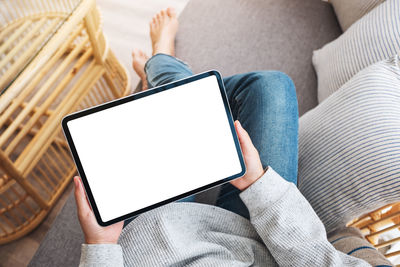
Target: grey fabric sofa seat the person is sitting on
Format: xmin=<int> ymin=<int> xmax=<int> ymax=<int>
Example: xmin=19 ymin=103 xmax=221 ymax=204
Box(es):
xmin=30 ymin=0 xmax=340 ymax=266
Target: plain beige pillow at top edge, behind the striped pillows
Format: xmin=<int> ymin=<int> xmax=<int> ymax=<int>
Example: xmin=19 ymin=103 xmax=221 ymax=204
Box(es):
xmin=328 ymin=0 xmax=385 ymax=31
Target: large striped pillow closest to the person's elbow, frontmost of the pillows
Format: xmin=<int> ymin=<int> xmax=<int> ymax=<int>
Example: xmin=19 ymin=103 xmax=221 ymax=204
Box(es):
xmin=298 ymin=55 xmax=400 ymax=232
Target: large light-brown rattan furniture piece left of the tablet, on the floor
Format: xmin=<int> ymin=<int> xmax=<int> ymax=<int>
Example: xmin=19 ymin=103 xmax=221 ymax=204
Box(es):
xmin=0 ymin=0 xmax=130 ymax=244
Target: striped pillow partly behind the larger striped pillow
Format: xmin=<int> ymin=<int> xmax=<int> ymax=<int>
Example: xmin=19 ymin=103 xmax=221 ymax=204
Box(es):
xmin=313 ymin=0 xmax=400 ymax=102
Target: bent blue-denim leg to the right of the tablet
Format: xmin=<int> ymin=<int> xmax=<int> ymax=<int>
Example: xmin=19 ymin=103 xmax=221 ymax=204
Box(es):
xmin=224 ymin=71 xmax=298 ymax=184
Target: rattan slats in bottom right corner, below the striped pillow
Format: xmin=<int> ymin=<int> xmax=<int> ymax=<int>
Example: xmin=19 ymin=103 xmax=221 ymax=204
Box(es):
xmin=347 ymin=202 xmax=400 ymax=259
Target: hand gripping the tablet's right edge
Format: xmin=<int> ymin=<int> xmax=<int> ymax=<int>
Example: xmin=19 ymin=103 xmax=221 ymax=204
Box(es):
xmin=231 ymin=120 xmax=264 ymax=190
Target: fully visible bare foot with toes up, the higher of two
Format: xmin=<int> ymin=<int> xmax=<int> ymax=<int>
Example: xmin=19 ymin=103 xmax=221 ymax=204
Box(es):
xmin=150 ymin=7 xmax=178 ymax=56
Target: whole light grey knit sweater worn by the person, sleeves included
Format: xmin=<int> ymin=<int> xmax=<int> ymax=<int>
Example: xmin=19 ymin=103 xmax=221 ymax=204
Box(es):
xmin=80 ymin=168 xmax=371 ymax=266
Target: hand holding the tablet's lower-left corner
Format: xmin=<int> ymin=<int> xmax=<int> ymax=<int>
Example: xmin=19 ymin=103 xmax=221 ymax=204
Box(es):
xmin=74 ymin=176 xmax=124 ymax=244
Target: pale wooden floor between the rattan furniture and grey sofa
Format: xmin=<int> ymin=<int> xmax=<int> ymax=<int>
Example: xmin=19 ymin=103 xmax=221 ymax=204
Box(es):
xmin=0 ymin=0 xmax=189 ymax=267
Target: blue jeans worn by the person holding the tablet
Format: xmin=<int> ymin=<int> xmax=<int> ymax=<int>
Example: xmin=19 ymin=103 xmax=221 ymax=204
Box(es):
xmin=145 ymin=54 xmax=299 ymax=218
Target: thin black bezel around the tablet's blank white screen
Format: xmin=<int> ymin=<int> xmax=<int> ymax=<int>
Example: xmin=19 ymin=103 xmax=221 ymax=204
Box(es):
xmin=61 ymin=70 xmax=246 ymax=226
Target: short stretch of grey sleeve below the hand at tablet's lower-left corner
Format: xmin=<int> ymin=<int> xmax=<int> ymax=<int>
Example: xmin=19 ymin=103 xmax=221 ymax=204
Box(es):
xmin=79 ymin=244 xmax=124 ymax=267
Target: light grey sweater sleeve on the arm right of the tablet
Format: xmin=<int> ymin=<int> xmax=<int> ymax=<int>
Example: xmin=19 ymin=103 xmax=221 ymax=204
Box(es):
xmin=240 ymin=168 xmax=371 ymax=266
